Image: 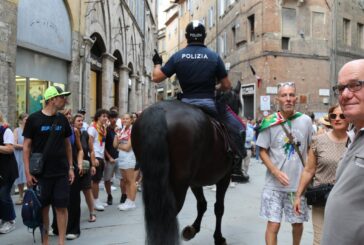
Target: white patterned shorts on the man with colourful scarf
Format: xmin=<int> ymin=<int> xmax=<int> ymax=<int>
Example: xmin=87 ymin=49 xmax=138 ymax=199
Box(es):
xmin=260 ymin=189 xmax=309 ymax=224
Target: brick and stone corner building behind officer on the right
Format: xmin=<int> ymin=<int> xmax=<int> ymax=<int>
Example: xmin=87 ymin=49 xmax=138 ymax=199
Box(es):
xmin=165 ymin=0 xmax=364 ymax=118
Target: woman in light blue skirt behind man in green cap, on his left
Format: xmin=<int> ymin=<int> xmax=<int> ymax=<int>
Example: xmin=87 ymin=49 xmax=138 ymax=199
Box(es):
xmin=14 ymin=113 xmax=28 ymax=205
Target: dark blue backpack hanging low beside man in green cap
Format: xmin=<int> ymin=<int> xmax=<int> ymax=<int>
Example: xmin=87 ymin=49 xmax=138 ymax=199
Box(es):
xmin=21 ymin=188 xmax=43 ymax=242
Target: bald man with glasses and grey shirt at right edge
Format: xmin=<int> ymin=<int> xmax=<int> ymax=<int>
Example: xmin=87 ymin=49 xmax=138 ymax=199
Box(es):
xmin=321 ymin=59 xmax=364 ymax=245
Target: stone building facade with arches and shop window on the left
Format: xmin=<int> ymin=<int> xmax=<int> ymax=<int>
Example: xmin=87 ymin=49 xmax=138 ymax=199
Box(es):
xmin=0 ymin=0 xmax=157 ymax=125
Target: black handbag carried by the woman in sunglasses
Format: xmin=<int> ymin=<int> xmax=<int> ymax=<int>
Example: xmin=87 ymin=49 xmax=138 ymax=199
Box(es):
xmin=305 ymin=184 xmax=334 ymax=206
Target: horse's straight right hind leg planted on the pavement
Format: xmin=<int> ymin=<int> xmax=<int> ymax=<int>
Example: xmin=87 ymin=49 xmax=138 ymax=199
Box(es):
xmin=214 ymin=173 xmax=230 ymax=245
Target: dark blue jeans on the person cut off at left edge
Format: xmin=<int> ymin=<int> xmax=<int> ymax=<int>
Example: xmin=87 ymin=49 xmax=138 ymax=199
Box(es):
xmin=0 ymin=180 xmax=16 ymax=222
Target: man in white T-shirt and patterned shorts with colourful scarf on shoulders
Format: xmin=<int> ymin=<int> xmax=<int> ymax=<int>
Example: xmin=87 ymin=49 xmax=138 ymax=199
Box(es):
xmin=257 ymin=82 xmax=312 ymax=245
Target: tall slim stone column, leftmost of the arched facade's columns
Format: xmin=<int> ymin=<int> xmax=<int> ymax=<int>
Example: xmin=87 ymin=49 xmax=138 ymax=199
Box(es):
xmin=81 ymin=37 xmax=95 ymax=117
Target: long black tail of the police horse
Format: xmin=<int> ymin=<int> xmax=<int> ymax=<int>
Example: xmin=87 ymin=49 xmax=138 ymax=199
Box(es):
xmin=132 ymin=106 xmax=179 ymax=245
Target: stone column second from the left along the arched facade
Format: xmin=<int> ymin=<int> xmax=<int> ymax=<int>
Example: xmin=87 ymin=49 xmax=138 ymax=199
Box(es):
xmin=101 ymin=53 xmax=116 ymax=110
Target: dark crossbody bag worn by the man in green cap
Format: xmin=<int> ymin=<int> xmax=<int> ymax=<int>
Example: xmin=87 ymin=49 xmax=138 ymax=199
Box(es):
xmin=29 ymin=113 xmax=59 ymax=176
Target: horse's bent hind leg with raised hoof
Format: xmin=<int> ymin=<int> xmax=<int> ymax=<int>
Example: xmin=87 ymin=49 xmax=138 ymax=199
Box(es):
xmin=182 ymin=187 xmax=207 ymax=241
